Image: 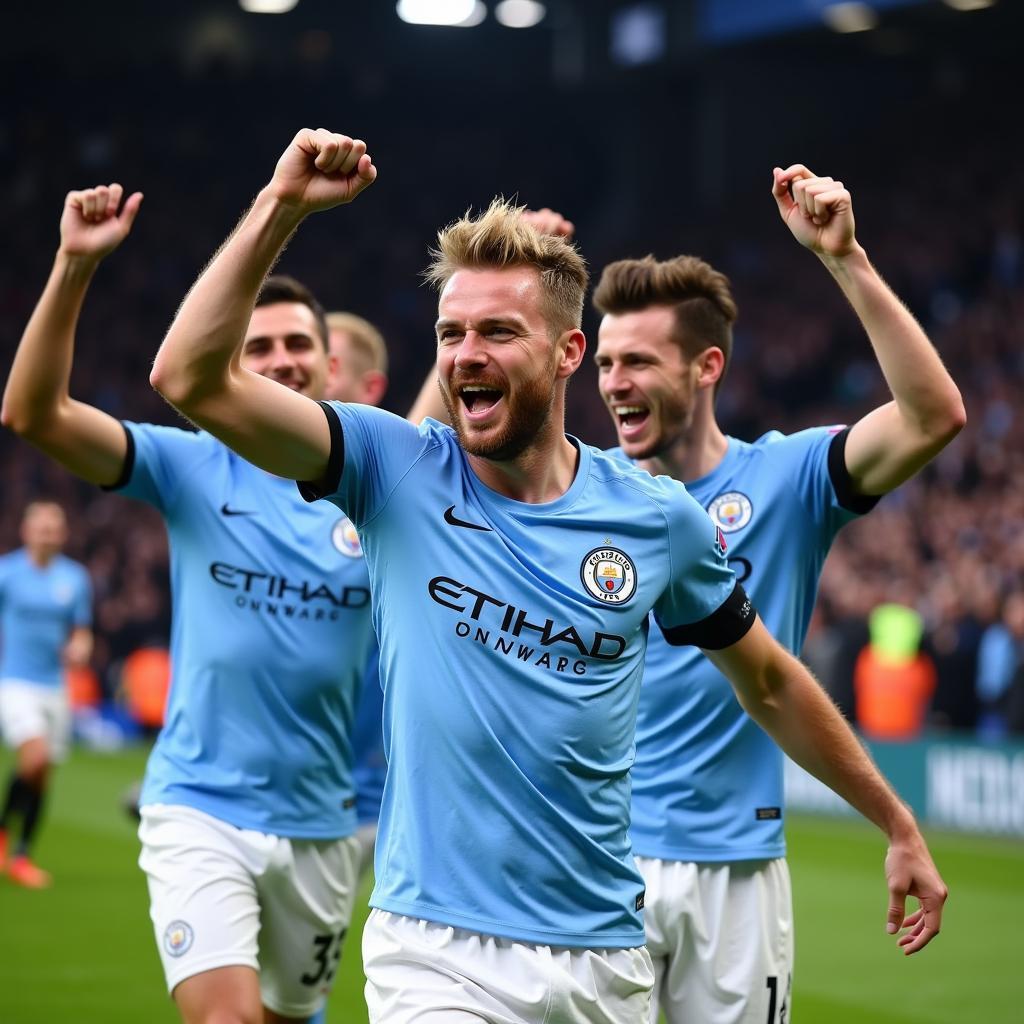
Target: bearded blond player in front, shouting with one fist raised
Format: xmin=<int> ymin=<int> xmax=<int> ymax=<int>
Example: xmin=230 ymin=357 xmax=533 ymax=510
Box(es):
xmin=151 ymin=129 xmax=942 ymax=1024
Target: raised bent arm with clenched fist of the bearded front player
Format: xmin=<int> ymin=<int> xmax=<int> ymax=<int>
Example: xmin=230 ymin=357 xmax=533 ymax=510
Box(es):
xmin=150 ymin=128 xmax=377 ymax=480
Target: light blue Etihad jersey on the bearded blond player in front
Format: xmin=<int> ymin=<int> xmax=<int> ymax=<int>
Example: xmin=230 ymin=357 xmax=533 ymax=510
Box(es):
xmin=301 ymin=403 xmax=753 ymax=948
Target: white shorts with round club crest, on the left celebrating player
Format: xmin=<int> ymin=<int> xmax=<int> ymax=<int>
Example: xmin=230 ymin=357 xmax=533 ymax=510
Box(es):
xmin=138 ymin=804 xmax=359 ymax=1018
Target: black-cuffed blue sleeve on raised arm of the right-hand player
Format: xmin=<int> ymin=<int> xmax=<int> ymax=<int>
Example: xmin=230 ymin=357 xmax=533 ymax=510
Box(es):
xmin=765 ymin=426 xmax=880 ymax=539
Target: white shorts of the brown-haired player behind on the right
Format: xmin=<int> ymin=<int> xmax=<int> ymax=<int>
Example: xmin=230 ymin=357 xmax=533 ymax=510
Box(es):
xmin=636 ymin=857 xmax=794 ymax=1024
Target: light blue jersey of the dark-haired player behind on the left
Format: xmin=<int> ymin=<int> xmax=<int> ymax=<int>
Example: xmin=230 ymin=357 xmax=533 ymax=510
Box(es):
xmin=118 ymin=423 xmax=373 ymax=839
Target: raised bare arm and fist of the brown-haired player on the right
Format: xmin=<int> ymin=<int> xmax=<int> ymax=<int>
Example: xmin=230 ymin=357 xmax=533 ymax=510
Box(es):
xmin=772 ymin=164 xmax=966 ymax=495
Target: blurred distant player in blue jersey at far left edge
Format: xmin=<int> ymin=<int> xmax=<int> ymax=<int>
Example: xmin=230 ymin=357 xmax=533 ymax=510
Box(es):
xmin=0 ymin=501 xmax=92 ymax=889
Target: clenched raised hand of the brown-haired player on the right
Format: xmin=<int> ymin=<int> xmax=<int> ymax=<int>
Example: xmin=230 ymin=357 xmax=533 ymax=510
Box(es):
xmin=771 ymin=164 xmax=857 ymax=257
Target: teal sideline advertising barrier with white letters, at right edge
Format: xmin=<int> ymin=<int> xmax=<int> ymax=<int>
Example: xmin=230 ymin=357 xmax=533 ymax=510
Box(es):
xmin=785 ymin=738 xmax=1024 ymax=839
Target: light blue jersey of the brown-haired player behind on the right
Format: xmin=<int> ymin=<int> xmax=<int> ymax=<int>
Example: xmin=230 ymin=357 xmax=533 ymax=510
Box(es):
xmin=610 ymin=427 xmax=878 ymax=861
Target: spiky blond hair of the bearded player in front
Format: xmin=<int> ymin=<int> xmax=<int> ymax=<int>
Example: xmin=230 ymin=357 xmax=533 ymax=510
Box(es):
xmin=424 ymin=198 xmax=590 ymax=334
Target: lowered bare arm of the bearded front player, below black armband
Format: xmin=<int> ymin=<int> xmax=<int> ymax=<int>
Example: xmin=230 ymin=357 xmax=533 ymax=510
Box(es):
xmin=705 ymin=620 xmax=947 ymax=953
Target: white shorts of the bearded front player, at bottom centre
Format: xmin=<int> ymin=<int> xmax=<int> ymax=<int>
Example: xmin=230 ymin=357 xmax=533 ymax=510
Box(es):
xmin=362 ymin=909 xmax=654 ymax=1024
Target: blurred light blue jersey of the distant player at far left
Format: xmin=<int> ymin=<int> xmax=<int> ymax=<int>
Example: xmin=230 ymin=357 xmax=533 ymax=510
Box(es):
xmin=0 ymin=548 xmax=92 ymax=687
